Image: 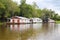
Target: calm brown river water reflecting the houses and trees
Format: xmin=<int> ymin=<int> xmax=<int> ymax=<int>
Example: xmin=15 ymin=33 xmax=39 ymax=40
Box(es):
xmin=0 ymin=23 xmax=60 ymax=40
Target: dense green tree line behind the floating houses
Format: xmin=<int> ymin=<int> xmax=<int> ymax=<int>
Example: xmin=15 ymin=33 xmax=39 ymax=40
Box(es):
xmin=0 ymin=0 xmax=60 ymax=21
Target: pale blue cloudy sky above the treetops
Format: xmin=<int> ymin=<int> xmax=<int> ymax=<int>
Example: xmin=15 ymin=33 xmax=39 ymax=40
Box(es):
xmin=13 ymin=0 xmax=60 ymax=15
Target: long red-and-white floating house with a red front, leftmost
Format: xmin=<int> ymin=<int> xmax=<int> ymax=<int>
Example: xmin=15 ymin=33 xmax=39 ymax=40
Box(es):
xmin=10 ymin=16 xmax=30 ymax=23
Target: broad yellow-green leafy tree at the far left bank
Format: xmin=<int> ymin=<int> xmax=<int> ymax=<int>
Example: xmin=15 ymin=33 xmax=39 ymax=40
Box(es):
xmin=0 ymin=0 xmax=20 ymax=21
